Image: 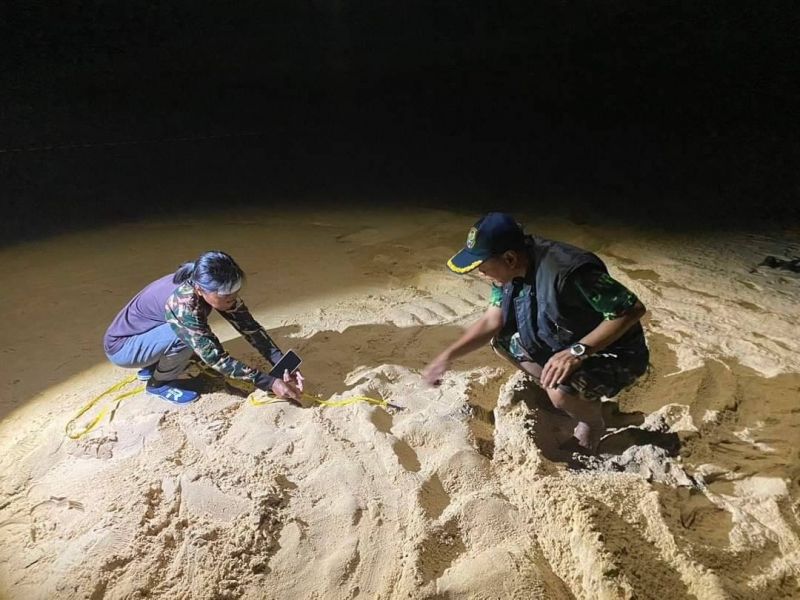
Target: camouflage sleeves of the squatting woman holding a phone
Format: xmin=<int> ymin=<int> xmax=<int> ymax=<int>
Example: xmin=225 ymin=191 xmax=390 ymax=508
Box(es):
xmin=164 ymin=283 xmax=282 ymax=389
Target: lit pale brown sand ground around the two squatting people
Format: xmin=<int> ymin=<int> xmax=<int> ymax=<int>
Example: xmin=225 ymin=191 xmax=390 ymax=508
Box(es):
xmin=0 ymin=210 xmax=800 ymax=600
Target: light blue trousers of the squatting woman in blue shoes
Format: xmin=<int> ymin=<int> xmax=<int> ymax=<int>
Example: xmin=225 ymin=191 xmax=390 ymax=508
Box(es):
xmin=108 ymin=323 xmax=192 ymax=381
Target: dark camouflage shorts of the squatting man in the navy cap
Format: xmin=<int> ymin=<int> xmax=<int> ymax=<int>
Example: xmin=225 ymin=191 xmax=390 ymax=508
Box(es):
xmin=491 ymin=333 xmax=650 ymax=400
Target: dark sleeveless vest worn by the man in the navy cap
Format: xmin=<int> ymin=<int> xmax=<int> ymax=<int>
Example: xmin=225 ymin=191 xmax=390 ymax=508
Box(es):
xmin=501 ymin=235 xmax=644 ymax=356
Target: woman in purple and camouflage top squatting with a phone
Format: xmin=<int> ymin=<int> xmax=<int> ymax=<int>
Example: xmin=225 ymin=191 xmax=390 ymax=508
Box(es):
xmin=103 ymin=251 xmax=303 ymax=404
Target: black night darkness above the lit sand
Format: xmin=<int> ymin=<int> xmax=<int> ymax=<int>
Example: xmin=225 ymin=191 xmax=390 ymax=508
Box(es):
xmin=0 ymin=0 xmax=800 ymax=243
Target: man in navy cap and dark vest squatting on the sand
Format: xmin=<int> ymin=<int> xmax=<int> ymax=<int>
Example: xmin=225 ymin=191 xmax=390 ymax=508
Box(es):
xmin=423 ymin=212 xmax=649 ymax=454
